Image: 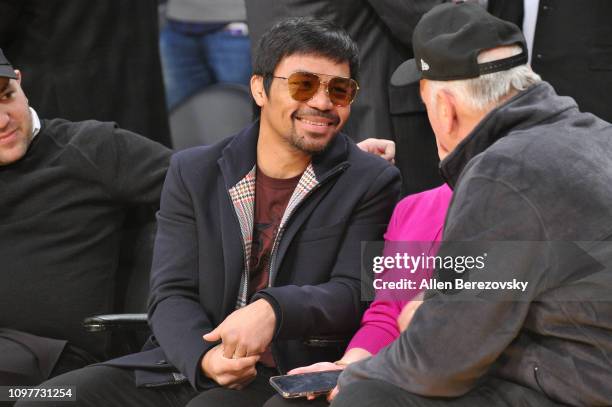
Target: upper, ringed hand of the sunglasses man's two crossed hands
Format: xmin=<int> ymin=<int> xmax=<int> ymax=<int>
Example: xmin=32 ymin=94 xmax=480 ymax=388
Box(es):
xmin=204 ymin=299 xmax=276 ymax=359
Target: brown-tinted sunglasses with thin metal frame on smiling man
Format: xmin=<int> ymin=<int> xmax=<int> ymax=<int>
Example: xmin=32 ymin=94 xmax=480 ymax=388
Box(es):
xmin=272 ymin=72 xmax=359 ymax=106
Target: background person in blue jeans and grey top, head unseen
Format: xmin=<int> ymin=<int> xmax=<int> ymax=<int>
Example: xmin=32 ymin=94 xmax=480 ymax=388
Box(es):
xmin=159 ymin=0 xmax=251 ymax=111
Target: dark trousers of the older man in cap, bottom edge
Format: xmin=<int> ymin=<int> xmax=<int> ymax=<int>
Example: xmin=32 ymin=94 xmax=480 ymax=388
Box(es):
xmin=265 ymin=379 xmax=558 ymax=407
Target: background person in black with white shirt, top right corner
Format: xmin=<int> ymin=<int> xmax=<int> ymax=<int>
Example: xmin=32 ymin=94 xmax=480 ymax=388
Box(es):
xmin=488 ymin=0 xmax=612 ymax=122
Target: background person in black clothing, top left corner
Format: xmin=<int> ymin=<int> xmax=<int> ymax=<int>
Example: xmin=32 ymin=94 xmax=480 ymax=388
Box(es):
xmin=0 ymin=0 xmax=171 ymax=147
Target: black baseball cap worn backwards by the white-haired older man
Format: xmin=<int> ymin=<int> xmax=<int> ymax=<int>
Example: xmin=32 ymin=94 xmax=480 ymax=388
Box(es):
xmin=391 ymin=2 xmax=527 ymax=86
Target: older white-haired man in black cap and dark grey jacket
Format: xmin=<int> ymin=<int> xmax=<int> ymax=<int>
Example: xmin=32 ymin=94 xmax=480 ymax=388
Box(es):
xmin=332 ymin=3 xmax=612 ymax=407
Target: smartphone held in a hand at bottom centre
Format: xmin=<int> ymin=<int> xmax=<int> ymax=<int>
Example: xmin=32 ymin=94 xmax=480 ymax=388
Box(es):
xmin=270 ymin=370 xmax=342 ymax=399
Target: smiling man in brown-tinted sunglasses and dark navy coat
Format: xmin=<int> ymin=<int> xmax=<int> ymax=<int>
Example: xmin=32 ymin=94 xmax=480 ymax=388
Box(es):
xmin=22 ymin=18 xmax=400 ymax=406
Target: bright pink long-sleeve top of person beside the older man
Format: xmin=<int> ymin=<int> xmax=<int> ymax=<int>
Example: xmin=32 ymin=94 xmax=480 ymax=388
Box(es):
xmin=347 ymin=184 xmax=452 ymax=354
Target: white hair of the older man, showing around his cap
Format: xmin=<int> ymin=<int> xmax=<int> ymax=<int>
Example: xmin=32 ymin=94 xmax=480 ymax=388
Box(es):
xmin=430 ymin=45 xmax=542 ymax=111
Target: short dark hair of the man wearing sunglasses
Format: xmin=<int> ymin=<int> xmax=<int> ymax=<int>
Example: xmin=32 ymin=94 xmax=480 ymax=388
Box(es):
xmin=253 ymin=17 xmax=359 ymax=93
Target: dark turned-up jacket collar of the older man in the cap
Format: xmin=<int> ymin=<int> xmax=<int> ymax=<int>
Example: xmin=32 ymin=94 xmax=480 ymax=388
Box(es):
xmin=440 ymin=82 xmax=577 ymax=188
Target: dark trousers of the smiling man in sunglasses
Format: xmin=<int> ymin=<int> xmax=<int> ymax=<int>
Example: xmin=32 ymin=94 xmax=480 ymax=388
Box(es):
xmin=15 ymin=366 xmax=277 ymax=407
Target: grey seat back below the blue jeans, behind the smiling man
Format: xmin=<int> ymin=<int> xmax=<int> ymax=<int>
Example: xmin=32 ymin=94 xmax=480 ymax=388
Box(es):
xmin=170 ymin=84 xmax=253 ymax=150
